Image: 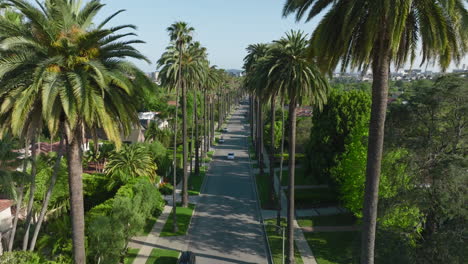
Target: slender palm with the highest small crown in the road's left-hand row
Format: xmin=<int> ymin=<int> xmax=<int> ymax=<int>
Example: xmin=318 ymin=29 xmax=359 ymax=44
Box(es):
xmin=167 ymin=22 xmax=195 ymax=207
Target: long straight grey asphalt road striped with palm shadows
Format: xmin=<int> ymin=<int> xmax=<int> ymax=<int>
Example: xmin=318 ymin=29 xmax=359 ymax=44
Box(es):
xmin=188 ymin=105 xmax=268 ymax=264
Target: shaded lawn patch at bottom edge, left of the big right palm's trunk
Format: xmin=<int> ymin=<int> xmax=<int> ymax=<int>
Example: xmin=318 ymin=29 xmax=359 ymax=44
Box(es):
xmin=304 ymin=231 xmax=360 ymax=264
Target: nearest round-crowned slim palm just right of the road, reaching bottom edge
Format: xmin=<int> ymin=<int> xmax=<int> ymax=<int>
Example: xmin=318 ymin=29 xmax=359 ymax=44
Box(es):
xmin=261 ymin=31 xmax=329 ymax=263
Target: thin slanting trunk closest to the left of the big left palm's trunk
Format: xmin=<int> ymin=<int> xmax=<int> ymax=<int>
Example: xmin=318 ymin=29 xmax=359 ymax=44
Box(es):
xmin=29 ymin=136 xmax=63 ymax=251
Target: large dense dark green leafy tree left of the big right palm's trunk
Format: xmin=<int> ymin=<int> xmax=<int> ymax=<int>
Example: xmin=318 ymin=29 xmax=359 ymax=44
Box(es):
xmin=305 ymin=89 xmax=371 ymax=182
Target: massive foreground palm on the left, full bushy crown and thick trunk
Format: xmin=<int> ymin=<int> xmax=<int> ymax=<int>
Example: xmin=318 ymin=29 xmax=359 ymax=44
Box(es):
xmin=0 ymin=0 xmax=151 ymax=264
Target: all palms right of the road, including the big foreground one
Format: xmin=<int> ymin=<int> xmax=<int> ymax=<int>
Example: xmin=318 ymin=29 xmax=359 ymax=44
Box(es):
xmin=244 ymin=0 xmax=468 ymax=264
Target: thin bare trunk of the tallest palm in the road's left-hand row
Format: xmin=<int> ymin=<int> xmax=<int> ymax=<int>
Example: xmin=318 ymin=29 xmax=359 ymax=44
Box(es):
xmin=182 ymin=81 xmax=188 ymax=207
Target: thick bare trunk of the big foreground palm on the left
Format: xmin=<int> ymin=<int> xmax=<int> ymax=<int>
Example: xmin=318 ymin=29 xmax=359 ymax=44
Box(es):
xmin=67 ymin=127 xmax=86 ymax=264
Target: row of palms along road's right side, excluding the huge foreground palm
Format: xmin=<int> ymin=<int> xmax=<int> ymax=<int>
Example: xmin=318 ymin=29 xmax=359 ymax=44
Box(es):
xmin=244 ymin=31 xmax=329 ymax=263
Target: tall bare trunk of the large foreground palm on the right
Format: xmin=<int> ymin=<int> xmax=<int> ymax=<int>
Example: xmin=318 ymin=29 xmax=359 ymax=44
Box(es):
xmin=361 ymin=46 xmax=390 ymax=264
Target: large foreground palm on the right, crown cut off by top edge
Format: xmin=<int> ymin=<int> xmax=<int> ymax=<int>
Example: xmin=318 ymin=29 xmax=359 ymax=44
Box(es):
xmin=283 ymin=0 xmax=468 ymax=263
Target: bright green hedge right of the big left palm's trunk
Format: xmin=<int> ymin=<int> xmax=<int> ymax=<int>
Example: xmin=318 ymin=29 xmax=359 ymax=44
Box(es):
xmin=87 ymin=177 xmax=164 ymax=263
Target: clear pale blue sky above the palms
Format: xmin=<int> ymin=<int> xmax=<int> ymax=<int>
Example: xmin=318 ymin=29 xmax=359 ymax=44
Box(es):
xmin=98 ymin=0 xmax=468 ymax=72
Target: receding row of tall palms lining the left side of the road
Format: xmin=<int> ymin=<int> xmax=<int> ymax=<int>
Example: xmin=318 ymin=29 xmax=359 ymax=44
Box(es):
xmin=158 ymin=22 xmax=236 ymax=232
